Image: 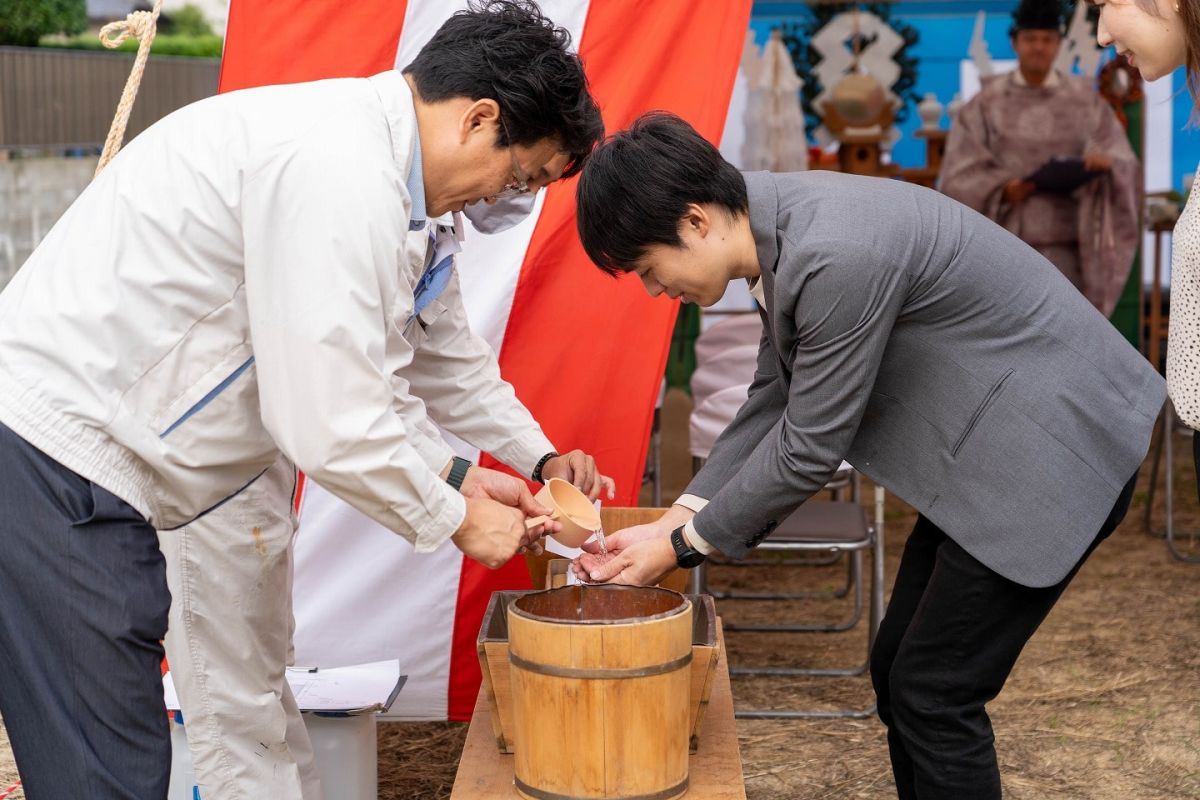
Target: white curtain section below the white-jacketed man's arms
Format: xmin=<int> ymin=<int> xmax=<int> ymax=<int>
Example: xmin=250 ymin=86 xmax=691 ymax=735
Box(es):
xmin=293 ymin=481 xmax=462 ymax=720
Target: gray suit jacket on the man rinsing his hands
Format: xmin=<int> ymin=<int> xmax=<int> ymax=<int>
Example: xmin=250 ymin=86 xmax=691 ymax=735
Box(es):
xmin=688 ymin=172 xmax=1166 ymax=587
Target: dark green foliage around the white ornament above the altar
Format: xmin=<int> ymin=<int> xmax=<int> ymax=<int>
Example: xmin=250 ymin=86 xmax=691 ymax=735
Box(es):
xmin=780 ymin=0 xmax=920 ymax=136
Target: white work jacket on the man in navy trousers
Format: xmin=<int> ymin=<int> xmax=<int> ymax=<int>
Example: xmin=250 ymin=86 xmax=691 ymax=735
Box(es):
xmin=0 ymin=71 xmax=552 ymax=552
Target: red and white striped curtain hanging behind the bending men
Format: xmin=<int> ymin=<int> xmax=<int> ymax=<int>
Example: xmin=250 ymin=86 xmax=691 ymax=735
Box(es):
xmin=221 ymin=0 xmax=751 ymax=720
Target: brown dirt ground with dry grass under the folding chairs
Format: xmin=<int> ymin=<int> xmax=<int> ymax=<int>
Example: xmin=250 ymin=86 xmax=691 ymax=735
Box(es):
xmin=0 ymin=392 xmax=1200 ymax=800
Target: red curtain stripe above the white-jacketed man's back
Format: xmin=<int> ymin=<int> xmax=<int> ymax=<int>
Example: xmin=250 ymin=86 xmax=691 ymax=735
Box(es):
xmin=218 ymin=0 xmax=408 ymax=91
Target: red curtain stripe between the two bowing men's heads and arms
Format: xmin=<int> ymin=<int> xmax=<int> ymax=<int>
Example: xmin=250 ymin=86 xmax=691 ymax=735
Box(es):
xmin=449 ymin=0 xmax=750 ymax=720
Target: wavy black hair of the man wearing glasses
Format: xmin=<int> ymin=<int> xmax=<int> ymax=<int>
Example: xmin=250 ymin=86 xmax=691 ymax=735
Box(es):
xmin=403 ymin=0 xmax=604 ymax=178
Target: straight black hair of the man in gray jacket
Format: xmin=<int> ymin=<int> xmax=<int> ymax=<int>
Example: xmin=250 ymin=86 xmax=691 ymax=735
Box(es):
xmin=575 ymin=112 xmax=749 ymax=276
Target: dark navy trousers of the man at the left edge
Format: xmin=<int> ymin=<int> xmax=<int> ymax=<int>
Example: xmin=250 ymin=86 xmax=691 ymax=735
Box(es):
xmin=0 ymin=426 xmax=170 ymax=800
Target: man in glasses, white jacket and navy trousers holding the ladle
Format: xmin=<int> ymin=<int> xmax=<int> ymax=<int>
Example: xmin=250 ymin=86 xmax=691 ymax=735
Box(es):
xmin=0 ymin=0 xmax=601 ymax=800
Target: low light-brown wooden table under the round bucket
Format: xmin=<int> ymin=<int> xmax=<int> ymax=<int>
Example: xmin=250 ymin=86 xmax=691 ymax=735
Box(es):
xmin=450 ymin=623 xmax=746 ymax=800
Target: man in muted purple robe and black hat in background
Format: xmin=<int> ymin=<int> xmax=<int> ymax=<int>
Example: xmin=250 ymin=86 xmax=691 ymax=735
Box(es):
xmin=940 ymin=0 xmax=1141 ymax=314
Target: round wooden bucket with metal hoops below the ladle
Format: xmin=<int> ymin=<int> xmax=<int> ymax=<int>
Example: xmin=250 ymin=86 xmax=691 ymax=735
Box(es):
xmin=508 ymin=585 xmax=692 ymax=800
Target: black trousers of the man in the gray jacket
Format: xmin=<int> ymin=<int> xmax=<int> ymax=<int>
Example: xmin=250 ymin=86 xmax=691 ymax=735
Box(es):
xmin=871 ymin=475 xmax=1136 ymax=800
